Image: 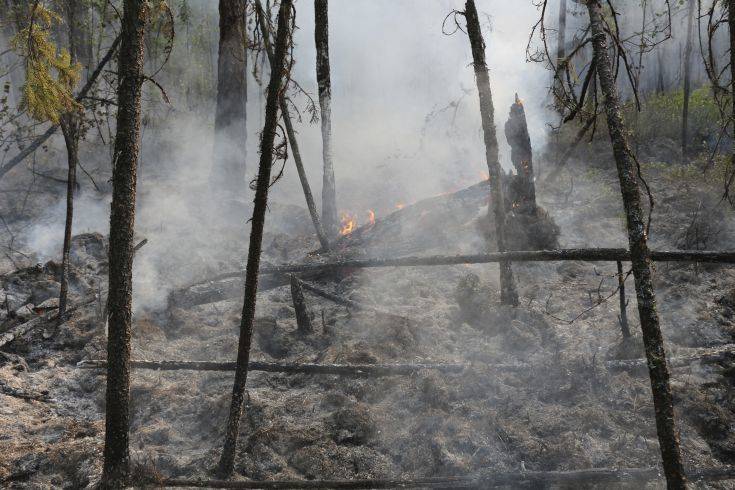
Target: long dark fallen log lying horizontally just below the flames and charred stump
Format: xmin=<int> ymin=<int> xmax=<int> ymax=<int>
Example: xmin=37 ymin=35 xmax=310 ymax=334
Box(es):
xmin=261 ymin=248 xmax=735 ymax=274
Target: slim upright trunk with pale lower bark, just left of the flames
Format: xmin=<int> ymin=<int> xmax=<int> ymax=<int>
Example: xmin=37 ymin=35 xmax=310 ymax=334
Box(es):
xmin=314 ymin=0 xmax=339 ymax=240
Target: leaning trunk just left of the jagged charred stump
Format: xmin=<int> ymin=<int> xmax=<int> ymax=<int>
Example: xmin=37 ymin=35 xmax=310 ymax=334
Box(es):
xmin=464 ymin=0 xmax=518 ymax=305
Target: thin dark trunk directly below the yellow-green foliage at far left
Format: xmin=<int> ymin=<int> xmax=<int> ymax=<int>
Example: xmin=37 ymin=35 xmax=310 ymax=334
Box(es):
xmin=59 ymin=117 xmax=79 ymax=320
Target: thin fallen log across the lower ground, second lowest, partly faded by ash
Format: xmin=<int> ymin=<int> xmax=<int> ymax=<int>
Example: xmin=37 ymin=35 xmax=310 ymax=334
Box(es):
xmin=77 ymin=344 xmax=735 ymax=376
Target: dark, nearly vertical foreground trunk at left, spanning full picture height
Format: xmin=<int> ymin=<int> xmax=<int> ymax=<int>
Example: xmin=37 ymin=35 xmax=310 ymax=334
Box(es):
xmin=102 ymin=0 xmax=150 ymax=488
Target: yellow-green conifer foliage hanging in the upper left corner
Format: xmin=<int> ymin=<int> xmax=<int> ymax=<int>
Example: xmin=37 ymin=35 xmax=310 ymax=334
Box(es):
xmin=11 ymin=2 xmax=81 ymax=124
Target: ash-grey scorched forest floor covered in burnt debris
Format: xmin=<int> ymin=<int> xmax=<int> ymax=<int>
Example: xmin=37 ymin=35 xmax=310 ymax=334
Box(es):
xmin=0 ymin=159 xmax=735 ymax=488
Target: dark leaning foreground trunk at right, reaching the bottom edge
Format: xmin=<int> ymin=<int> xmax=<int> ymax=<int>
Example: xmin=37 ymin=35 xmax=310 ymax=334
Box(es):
xmin=587 ymin=0 xmax=686 ymax=489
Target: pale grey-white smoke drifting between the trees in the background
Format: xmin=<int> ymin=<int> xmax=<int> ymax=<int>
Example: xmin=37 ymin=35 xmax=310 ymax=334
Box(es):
xmin=15 ymin=0 xmax=549 ymax=311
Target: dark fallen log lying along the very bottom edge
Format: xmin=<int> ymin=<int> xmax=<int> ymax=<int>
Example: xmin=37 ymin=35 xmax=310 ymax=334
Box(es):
xmin=150 ymin=466 xmax=735 ymax=489
